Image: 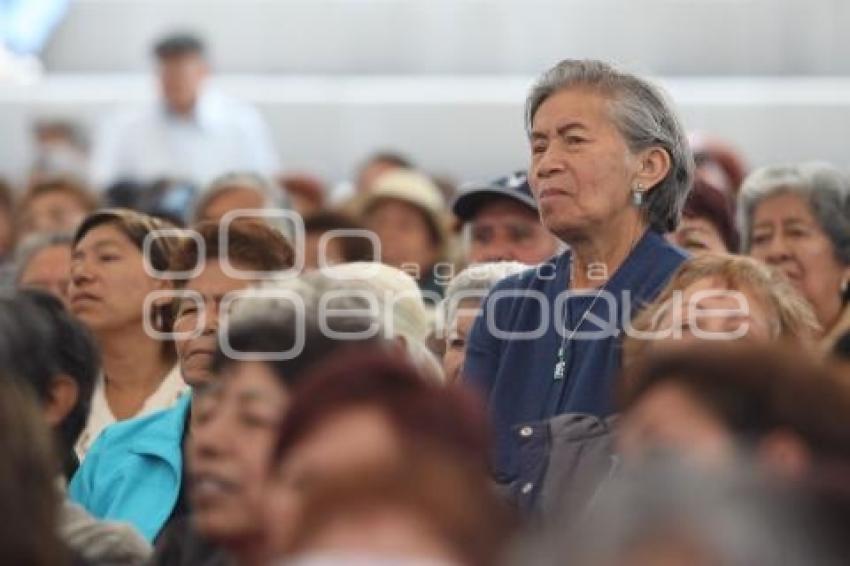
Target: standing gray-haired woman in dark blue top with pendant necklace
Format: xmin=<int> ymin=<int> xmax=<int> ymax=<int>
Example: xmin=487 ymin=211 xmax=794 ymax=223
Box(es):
xmin=464 ymin=60 xmax=694 ymax=493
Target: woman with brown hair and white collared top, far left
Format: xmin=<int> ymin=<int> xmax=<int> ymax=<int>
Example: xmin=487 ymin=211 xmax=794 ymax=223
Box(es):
xmin=69 ymin=209 xmax=186 ymax=460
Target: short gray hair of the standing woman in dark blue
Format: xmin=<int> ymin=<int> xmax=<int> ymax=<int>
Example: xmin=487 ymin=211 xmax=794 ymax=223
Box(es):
xmin=525 ymin=59 xmax=694 ymax=233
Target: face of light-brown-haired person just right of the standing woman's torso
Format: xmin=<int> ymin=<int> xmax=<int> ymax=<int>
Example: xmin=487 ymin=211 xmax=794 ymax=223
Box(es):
xmin=654 ymin=277 xmax=779 ymax=347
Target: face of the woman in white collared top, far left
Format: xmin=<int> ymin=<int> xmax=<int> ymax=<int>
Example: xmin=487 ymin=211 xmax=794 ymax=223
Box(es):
xmin=68 ymin=224 xmax=171 ymax=333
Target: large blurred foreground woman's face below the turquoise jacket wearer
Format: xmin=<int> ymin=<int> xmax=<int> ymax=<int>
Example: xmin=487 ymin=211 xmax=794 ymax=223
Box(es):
xmin=186 ymin=362 xmax=289 ymax=546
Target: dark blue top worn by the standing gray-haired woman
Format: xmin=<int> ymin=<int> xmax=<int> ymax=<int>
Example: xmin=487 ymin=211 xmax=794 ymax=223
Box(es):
xmin=464 ymin=231 xmax=687 ymax=483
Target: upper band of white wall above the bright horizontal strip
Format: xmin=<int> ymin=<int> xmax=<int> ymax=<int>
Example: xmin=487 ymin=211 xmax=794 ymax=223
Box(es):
xmin=41 ymin=0 xmax=850 ymax=75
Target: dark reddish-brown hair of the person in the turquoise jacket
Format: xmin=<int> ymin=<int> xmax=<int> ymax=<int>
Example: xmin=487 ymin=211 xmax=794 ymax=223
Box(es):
xmin=170 ymin=218 xmax=295 ymax=280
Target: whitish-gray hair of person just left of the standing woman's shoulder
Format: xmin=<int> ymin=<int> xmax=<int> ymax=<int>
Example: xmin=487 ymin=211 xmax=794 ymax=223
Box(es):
xmin=437 ymin=261 xmax=531 ymax=336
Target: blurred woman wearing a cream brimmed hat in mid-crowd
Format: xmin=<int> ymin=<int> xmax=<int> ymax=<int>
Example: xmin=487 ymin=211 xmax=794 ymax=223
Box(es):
xmin=362 ymin=169 xmax=446 ymax=305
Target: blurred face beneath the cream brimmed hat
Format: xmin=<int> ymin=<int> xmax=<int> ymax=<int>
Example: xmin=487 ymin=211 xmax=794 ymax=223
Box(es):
xmin=366 ymin=199 xmax=437 ymax=277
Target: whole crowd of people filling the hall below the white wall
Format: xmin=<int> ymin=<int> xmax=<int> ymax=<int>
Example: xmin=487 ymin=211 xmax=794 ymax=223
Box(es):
xmin=0 ymin=45 xmax=850 ymax=566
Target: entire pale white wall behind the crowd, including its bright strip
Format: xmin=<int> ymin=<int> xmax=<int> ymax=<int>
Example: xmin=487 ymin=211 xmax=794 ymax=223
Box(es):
xmin=0 ymin=0 xmax=850 ymax=190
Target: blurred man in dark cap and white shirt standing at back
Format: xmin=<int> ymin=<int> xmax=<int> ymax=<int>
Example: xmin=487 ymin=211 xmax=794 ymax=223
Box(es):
xmin=91 ymin=34 xmax=280 ymax=193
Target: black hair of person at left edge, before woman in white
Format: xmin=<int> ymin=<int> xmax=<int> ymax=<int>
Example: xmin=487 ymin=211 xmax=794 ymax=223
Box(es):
xmin=0 ymin=290 xmax=100 ymax=478
